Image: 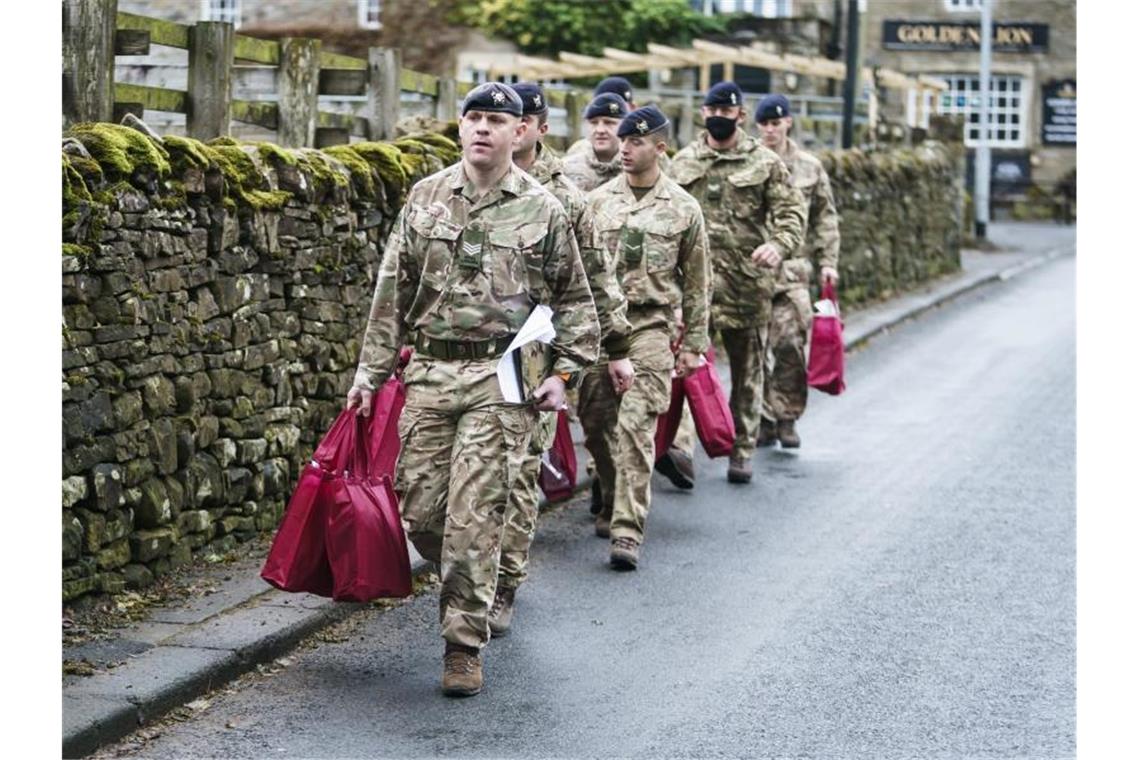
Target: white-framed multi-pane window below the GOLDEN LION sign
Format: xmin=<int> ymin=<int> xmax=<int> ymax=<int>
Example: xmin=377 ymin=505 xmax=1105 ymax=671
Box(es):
xmin=938 ymin=74 xmax=1028 ymax=148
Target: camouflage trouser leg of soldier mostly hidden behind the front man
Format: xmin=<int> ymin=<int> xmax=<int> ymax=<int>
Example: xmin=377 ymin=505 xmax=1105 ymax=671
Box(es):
xmin=498 ymin=411 xmax=557 ymax=588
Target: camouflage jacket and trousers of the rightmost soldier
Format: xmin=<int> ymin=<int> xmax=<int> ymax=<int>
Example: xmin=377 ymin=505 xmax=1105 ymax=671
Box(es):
xmin=764 ymin=139 xmax=839 ymax=422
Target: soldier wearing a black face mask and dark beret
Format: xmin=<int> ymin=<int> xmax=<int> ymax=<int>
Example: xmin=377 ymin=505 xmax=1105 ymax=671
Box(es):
xmin=673 ymin=82 xmax=804 ymax=483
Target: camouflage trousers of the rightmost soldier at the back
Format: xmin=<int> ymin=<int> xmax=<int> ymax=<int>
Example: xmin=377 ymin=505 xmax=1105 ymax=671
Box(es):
xmin=764 ymin=287 xmax=812 ymax=422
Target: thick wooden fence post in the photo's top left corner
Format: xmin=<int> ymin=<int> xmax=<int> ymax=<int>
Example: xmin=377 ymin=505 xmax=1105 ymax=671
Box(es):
xmin=63 ymin=0 xmax=119 ymax=126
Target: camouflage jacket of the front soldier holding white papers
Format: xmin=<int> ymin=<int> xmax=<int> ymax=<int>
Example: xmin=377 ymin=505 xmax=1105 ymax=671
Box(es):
xmin=353 ymin=161 xmax=599 ymax=389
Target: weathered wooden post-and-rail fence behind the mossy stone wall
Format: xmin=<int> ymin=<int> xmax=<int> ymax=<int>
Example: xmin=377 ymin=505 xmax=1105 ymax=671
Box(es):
xmin=63 ymin=0 xmax=589 ymax=147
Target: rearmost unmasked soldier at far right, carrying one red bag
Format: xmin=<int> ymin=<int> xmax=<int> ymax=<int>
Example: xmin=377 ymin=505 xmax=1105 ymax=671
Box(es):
xmin=756 ymin=95 xmax=839 ymax=449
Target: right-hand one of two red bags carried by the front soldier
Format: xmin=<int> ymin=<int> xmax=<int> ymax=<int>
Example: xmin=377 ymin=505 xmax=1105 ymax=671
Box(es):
xmin=325 ymin=418 xmax=412 ymax=602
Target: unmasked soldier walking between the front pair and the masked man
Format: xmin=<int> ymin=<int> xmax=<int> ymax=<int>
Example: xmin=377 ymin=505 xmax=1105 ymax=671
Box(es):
xmin=578 ymin=106 xmax=710 ymax=570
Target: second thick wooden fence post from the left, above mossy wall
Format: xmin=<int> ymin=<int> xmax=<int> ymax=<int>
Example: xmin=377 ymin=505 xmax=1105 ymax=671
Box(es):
xmin=186 ymin=22 xmax=234 ymax=140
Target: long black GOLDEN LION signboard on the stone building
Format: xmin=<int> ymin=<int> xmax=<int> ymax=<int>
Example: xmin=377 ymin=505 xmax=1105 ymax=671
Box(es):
xmin=882 ymin=19 xmax=1049 ymax=52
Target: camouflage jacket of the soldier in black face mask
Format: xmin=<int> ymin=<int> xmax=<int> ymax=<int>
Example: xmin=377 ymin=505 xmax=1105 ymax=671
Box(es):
xmin=673 ymin=132 xmax=805 ymax=328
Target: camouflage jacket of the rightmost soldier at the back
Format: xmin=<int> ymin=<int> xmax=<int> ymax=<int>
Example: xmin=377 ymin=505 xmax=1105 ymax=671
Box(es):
xmin=776 ymin=139 xmax=839 ymax=292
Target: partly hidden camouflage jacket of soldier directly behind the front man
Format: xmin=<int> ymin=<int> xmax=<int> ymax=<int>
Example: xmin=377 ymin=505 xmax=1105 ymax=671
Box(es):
xmin=530 ymin=142 xmax=632 ymax=359
